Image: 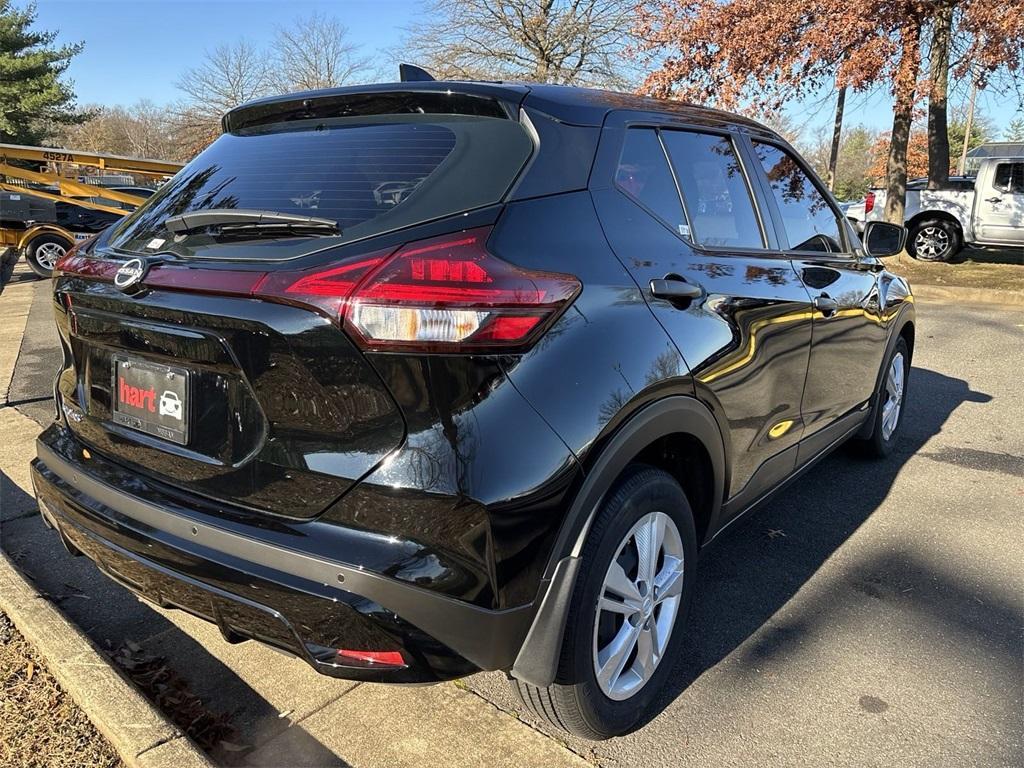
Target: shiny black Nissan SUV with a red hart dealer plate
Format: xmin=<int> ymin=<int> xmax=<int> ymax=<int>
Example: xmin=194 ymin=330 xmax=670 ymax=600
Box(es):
xmin=32 ymin=76 xmax=914 ymax=738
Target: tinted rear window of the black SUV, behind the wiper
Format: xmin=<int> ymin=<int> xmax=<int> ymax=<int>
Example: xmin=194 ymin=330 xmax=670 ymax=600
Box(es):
xmin=111 ymin=115 xmax=532 ymax=259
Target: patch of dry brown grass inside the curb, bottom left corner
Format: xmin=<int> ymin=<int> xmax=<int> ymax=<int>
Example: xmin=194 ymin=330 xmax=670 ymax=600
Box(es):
xmin=0 ymin=613 xmax=124 ymax=768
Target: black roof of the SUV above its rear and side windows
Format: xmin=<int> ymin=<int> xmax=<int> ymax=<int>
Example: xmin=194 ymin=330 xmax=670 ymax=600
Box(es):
xmin=222 ymin=80 xmax=776 ymax=135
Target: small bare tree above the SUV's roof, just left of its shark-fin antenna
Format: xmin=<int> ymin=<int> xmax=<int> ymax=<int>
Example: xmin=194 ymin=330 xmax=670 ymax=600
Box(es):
xmin=270 ymin=13 xmax=373 ymax=92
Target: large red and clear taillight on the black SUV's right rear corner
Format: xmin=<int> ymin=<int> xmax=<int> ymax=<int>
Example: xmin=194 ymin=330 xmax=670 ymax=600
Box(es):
xmin=255 ymin=227 xmax=580 ymax=351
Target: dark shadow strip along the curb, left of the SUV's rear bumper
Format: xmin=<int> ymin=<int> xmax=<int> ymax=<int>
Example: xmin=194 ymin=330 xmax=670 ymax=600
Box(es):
xmin=0 ymin=471 xmax=348 ymax=768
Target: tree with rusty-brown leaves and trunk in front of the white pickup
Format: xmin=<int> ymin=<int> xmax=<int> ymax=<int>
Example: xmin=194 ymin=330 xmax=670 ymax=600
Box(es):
xmin=637 ymin=0 xmax=1024 ymax=222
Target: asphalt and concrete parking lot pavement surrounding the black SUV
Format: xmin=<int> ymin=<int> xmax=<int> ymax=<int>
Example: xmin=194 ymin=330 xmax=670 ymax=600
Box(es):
xmin=0 ymin=268 xmax=1024 ymax=768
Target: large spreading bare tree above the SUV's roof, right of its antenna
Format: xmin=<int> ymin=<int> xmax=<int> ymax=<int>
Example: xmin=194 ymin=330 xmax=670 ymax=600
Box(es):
xmin=402 ymin=0 xmax=636 ymax=87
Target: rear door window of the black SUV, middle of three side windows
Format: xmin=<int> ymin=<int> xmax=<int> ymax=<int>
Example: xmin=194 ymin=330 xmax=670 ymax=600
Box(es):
xmin=662 ymin=130 xmax=765 ymax=248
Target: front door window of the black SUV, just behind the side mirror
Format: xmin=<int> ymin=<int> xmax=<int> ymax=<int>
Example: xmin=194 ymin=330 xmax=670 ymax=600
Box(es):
xmin=753 ymin=141 xmax=843 ymax=252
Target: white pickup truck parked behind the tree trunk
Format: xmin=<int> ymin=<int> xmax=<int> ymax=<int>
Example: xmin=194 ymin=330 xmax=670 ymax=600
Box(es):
xmin=847 ymin=158 xmax=1024 ymax=261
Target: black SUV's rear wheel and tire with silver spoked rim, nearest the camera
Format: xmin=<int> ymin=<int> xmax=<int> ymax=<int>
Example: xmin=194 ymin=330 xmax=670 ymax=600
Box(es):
xmin=512 ymin=464 xmax=696 ymax=739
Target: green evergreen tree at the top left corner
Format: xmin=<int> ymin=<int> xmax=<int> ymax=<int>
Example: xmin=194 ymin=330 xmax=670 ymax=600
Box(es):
xmin=0 ymin=0 xmax=89 ymax=144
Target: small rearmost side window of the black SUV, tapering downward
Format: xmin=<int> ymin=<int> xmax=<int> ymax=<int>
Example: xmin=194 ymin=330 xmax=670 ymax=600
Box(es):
xmin=615 ymin=128 xmax=686 ymax=234
